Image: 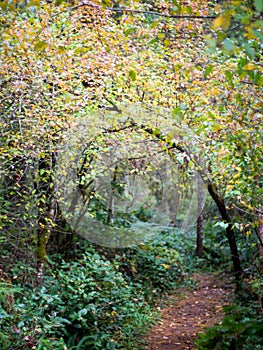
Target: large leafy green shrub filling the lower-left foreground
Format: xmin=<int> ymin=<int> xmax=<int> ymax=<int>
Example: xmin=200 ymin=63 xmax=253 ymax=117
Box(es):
xmin=0 ymin=253 xmax=156 ymax=350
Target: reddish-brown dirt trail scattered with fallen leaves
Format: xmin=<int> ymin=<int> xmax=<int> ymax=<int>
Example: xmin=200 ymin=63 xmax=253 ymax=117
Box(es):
xmin=146 ymin=273 xmax=234 ymax=350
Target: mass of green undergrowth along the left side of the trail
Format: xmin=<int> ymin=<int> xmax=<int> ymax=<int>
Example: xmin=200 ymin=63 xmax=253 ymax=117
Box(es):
xmin=0 ymin=232 xmax=196 ymax=350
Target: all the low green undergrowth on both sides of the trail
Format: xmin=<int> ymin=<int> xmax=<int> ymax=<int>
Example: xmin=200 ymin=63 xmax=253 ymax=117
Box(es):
xmin=0 ymin=224 xmax=263 ymax=350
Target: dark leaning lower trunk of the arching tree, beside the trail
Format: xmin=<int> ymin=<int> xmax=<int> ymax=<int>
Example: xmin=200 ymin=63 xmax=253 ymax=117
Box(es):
xmin=208 ymin=183 xmax=242 ymax=282
